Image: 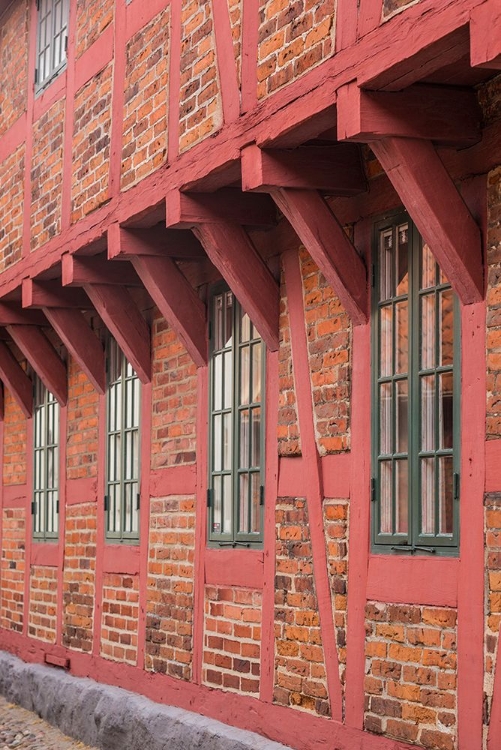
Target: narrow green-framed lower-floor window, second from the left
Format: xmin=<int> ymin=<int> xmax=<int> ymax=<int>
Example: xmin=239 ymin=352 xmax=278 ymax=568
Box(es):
xmin=105 ymin=338 xmax=141 ymax=543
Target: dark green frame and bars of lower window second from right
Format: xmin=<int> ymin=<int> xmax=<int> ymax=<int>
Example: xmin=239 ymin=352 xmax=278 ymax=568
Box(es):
xmin=207 ymin=283 xmax=266 ymax=548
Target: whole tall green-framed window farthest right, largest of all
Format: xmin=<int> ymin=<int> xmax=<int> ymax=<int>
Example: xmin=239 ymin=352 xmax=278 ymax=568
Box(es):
xmin=372 ymin=214 xmax=460 ymax=555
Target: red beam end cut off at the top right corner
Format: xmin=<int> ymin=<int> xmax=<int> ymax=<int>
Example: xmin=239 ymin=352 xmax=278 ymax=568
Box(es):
xmin=470 ymin=0 xmax=501 ymax=70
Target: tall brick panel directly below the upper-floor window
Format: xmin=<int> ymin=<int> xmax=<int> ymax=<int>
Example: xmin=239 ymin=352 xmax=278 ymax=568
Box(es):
xmin=31 ymin=99 xmax=64 ymax=250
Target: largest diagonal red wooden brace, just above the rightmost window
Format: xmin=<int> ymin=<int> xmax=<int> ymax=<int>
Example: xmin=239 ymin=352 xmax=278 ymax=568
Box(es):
xmin=371 ymin=138 xmax=484 ymax=305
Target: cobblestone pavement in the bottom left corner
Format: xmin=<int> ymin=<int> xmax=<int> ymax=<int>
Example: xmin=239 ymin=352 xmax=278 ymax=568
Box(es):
xmin=0 ymin=695 xmax=97 ymax=750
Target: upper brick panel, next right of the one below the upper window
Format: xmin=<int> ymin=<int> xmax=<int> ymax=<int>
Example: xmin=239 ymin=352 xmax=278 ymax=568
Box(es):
xmin=71 ymin=63 xmax=113 ymax=222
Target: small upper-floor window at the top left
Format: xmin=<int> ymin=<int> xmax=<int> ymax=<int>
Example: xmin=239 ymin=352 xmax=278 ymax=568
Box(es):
xmin=36 ymin=0 xmax=70 ymax=89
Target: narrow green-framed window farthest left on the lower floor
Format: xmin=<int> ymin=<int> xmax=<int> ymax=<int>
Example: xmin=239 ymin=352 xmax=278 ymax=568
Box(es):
xmin=32 ymin=376 xmax=59 ymax=541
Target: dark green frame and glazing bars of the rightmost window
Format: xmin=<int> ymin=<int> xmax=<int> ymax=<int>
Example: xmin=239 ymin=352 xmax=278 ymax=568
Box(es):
xmin=371 ymin=211 xmax=461 ymax=556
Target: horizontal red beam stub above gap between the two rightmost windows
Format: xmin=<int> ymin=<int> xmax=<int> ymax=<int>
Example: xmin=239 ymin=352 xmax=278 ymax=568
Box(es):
xmin=242 ymin=143 xmax=367 ymax=196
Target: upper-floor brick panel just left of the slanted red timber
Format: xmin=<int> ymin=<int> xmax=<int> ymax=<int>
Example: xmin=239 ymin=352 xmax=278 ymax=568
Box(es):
xmin=179 ymin=0 xmax=222 ymax=151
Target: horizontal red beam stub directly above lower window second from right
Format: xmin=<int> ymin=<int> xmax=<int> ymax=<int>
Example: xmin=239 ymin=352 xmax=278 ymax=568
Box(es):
xmin=166 ymin=188 xmax=277 ymax=229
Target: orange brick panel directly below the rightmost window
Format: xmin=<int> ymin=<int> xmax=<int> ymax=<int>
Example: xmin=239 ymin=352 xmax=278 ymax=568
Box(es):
xmin=365 ymin=602 xmax=457 ymax=750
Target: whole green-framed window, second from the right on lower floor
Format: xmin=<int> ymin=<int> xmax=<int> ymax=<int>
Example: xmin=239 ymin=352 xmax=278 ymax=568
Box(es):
xmin=208 ymin=286 xmax=266 ymax=547
